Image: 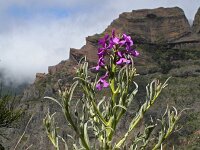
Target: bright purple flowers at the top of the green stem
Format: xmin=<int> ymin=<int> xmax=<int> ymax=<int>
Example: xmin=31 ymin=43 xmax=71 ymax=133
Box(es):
xmin=95 ymin=30 xmax=139 ymax=90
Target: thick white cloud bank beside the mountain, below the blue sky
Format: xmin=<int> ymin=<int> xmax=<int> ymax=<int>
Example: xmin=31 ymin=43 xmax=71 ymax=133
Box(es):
xmin=0 ymin=18 xmax=106 ymax=85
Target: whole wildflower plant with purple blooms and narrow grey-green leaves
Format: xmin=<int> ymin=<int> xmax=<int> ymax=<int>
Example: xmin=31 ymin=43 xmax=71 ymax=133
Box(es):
xmin=44 ymin=31 xmax=183 ymax=150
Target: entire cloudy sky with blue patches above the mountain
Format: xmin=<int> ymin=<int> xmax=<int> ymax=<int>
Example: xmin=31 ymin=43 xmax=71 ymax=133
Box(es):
xmin=0 ymin=0 xmax=200 ymax=84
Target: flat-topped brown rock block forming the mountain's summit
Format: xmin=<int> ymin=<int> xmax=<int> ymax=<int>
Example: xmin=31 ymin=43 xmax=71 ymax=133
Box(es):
xmin=106 ymin=7 xmax=190 ymax=43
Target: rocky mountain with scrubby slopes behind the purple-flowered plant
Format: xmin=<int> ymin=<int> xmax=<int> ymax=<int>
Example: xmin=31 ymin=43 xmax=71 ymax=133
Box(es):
xmin=3 ymin=7 xmax=200 ymax=150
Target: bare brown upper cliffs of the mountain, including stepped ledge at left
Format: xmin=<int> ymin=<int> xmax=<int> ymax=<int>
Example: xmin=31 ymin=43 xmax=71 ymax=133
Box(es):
xmin=70 ymin=7 xmax=200 ymax=62
